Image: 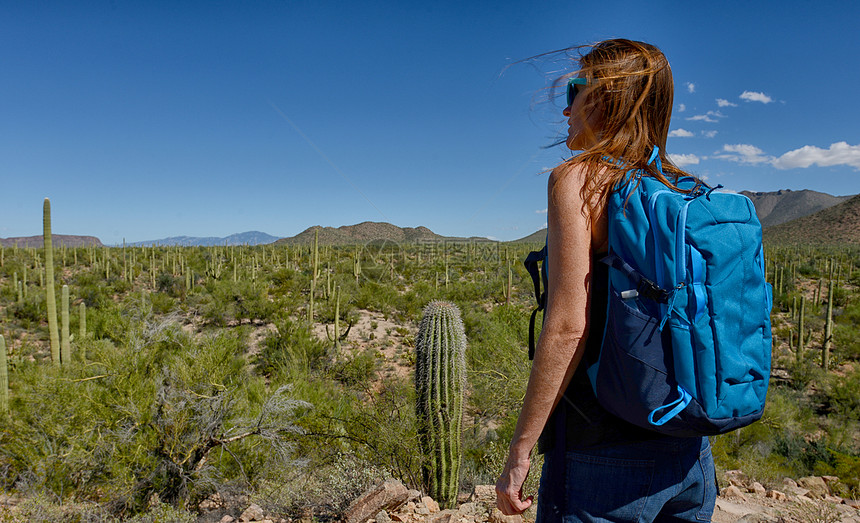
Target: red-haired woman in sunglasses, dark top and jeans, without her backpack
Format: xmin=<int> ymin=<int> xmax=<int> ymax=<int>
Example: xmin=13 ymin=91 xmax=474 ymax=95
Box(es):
xmin=496 ymin=39 xmax=716 ymax=522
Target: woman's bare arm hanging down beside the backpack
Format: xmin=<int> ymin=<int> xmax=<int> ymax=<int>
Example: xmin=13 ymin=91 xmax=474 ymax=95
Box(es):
xmin=496 ymin=165 xmax=592 ymax=515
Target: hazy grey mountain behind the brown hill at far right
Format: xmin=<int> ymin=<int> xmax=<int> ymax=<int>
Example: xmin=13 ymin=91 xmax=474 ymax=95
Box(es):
xmin=741 ymin=189 xmax=851 ymax=228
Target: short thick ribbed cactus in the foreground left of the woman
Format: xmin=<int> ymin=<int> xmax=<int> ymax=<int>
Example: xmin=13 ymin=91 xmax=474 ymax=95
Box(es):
xmin=415 ymin=301 xmax=466 ymax=507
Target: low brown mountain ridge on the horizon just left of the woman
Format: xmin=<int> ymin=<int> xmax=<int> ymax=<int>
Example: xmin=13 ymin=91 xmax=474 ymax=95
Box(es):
xmin=275 ymin=222 xmax=492 ymax=245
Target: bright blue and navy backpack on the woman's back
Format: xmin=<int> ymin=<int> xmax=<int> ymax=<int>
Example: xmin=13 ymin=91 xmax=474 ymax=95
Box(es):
xmin=526 ymin=147 xmax=772 ymax=436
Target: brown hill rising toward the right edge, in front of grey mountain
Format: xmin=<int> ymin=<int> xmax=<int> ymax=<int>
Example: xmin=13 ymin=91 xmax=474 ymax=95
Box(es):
xmin=764 ymin=194 xmax=860 ymax=245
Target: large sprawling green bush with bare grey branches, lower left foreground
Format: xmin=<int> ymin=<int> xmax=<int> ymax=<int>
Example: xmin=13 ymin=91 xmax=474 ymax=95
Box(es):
xmin=0 ymin=312 xmax=308 ymax=514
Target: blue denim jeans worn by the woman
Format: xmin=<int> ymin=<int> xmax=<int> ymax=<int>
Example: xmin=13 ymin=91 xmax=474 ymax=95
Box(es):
xmin=537 ymin=438 xmax=717 ymax=523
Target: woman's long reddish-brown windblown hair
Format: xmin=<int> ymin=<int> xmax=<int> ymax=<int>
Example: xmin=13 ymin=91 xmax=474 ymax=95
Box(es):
xmin=555 ymin=39 xmax=688 ymax=216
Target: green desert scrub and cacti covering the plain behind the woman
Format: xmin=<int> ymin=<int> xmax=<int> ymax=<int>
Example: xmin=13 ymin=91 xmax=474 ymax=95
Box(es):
xmin=0 ymin=201 xmax=860 ymax=521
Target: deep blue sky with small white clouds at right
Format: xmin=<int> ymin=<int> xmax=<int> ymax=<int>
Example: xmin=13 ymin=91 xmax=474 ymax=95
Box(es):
xmin=0 ymin=0 xmax=860 ymax=244
